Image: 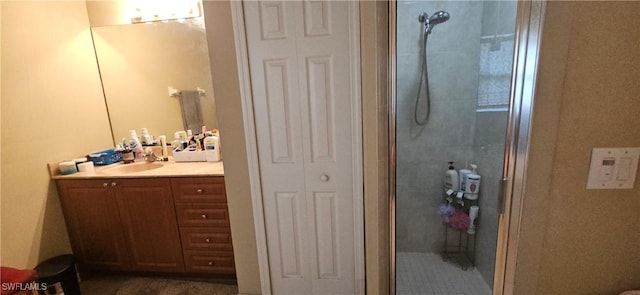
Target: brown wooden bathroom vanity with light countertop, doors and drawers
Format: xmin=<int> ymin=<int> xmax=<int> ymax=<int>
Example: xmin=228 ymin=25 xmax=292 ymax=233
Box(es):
xmin=50 ymin=161 xmax=235 ymax=277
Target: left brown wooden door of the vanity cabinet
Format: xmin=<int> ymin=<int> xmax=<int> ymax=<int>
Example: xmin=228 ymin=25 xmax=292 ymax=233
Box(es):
xmin=57 ymin=180 xmax=129 ymax=270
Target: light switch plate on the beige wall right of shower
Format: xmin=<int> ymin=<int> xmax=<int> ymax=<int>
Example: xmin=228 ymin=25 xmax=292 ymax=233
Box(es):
xmin=587 ymin=148 xmax=640 ymax=189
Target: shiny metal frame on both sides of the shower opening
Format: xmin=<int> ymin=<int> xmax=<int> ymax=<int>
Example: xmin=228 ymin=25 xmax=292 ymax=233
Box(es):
xmin=388 ymin=0 xmax=546 ymax=295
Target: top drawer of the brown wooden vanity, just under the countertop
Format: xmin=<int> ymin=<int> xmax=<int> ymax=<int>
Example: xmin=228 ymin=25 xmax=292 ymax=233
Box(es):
xmin=171 ymin=176 xmax=227 ymax=203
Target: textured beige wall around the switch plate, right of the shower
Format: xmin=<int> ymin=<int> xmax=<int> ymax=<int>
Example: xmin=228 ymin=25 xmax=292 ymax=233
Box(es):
xmin=515 ymin=2 xmax=640 ymax=294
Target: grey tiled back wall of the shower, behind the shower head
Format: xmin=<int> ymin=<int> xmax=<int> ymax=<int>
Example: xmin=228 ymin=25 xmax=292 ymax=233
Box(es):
xmin=396 ymin=1 xmax=482 ymax=253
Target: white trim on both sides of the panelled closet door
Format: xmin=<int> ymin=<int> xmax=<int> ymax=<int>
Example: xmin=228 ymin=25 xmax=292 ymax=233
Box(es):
xmin=230 ymin=1 xmax=365 ymax=295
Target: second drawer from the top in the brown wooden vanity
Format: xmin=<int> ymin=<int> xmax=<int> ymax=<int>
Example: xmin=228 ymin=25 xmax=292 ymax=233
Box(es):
xmin=176 ymin=203 xmax=229 ymax=228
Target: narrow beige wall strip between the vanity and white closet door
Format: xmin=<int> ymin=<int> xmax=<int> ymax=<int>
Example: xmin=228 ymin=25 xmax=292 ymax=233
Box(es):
xmin=204 ymin=1 xmax=261 ymax=294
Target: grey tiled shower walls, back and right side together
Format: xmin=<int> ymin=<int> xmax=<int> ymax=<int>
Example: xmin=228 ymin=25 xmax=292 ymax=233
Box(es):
xmin=396 ymin=1 xmax=515 ymax=290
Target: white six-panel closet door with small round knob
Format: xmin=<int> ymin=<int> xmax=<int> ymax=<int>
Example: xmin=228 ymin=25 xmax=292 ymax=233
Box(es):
xmin=243 ymin=1 xmax=363 ymax=294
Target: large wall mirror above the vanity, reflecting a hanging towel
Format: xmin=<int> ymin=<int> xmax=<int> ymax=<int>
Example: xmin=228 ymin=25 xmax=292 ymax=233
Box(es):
xmin=87 ymin=1 xmax=217 ymax=143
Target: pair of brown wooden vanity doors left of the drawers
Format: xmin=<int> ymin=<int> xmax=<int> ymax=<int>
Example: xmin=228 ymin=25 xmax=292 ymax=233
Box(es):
xmin=57 ymin=178 xmax=184 ymax=272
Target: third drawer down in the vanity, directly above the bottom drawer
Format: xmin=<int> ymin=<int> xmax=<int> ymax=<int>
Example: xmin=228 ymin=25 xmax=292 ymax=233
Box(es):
xmin=180 ymin=227 xmax=233 ymax=251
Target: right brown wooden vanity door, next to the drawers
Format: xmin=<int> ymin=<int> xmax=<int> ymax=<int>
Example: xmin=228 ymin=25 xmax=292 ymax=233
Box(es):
xmin=114 ymin=178 xmax=184 ymax=272
